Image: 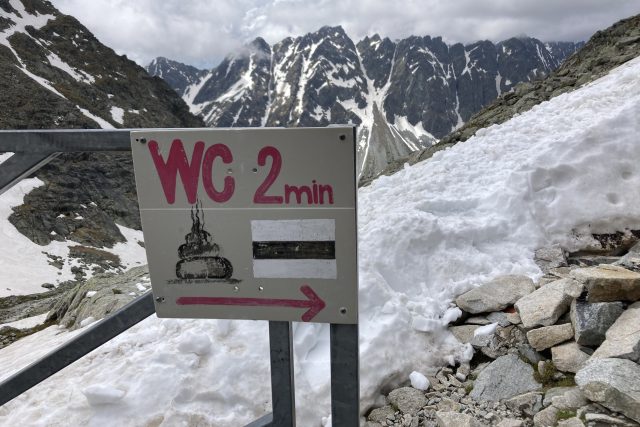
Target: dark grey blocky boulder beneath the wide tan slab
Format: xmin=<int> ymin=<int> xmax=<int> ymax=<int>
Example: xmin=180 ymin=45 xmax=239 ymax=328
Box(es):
xmin=571 ymin=299 xmax=624 ymax=347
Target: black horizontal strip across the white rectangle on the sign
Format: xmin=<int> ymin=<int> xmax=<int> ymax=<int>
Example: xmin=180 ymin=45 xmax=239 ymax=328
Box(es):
xmin=253 ymin=241 xmax=336 ymax=259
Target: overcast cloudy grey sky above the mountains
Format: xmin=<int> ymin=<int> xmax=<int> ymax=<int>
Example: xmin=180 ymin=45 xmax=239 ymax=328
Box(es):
xmin=52 ymin=0 xmax=640 ymax=68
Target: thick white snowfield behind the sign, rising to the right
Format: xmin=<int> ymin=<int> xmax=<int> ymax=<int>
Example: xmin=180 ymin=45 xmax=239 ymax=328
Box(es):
xmin=0 ymin=43 xmax=640 ymax=426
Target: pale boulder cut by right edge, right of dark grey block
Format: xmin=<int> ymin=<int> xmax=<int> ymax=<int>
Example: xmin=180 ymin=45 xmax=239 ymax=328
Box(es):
xmin=593 ymin=302 xmax=640 ymax=362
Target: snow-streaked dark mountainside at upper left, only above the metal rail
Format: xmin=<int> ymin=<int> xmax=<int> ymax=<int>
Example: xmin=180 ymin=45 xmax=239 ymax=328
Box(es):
xmin=0 ymin=0 xmax=200 ymax=128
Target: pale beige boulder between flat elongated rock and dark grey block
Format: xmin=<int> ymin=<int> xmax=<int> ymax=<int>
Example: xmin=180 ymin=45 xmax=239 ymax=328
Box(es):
xmin=515 ymin=279 xmax=583 ymax=328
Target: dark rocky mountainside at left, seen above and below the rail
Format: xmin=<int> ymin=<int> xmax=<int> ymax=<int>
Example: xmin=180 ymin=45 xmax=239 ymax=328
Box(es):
xmin=0 ymin=0 xmax=203 ymax=274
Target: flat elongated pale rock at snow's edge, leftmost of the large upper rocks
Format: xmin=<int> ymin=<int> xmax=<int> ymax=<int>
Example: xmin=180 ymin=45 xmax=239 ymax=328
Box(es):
xmin=456 ymin=275 xmax=535 ymax=313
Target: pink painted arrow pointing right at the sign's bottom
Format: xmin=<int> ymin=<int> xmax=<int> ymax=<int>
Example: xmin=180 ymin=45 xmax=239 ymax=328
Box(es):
xmin=176 ymin=285 xmax=326 ymax=322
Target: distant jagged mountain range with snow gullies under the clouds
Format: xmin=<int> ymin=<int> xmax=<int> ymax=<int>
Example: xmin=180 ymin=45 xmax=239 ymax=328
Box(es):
xmin=147 ymin=26 xmax=581 ymax=179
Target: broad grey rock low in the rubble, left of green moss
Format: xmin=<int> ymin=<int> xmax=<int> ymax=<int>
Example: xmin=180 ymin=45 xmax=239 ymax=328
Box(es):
xmin=470 ymin=354 xmax=540 ymax=401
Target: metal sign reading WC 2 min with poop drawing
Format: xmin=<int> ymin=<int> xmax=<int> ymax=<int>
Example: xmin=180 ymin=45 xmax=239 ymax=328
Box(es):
xmin=131 ymin=127 xmax=358 ymax=324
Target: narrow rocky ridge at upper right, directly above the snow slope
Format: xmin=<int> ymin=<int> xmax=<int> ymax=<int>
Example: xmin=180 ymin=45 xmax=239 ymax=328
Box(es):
xmin=363 ymin=15 xmax=640 ymax=184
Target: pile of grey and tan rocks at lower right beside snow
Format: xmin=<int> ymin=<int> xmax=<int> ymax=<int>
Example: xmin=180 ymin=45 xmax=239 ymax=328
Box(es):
xmin=367 ymin=239 xmax=640 ymax=427
